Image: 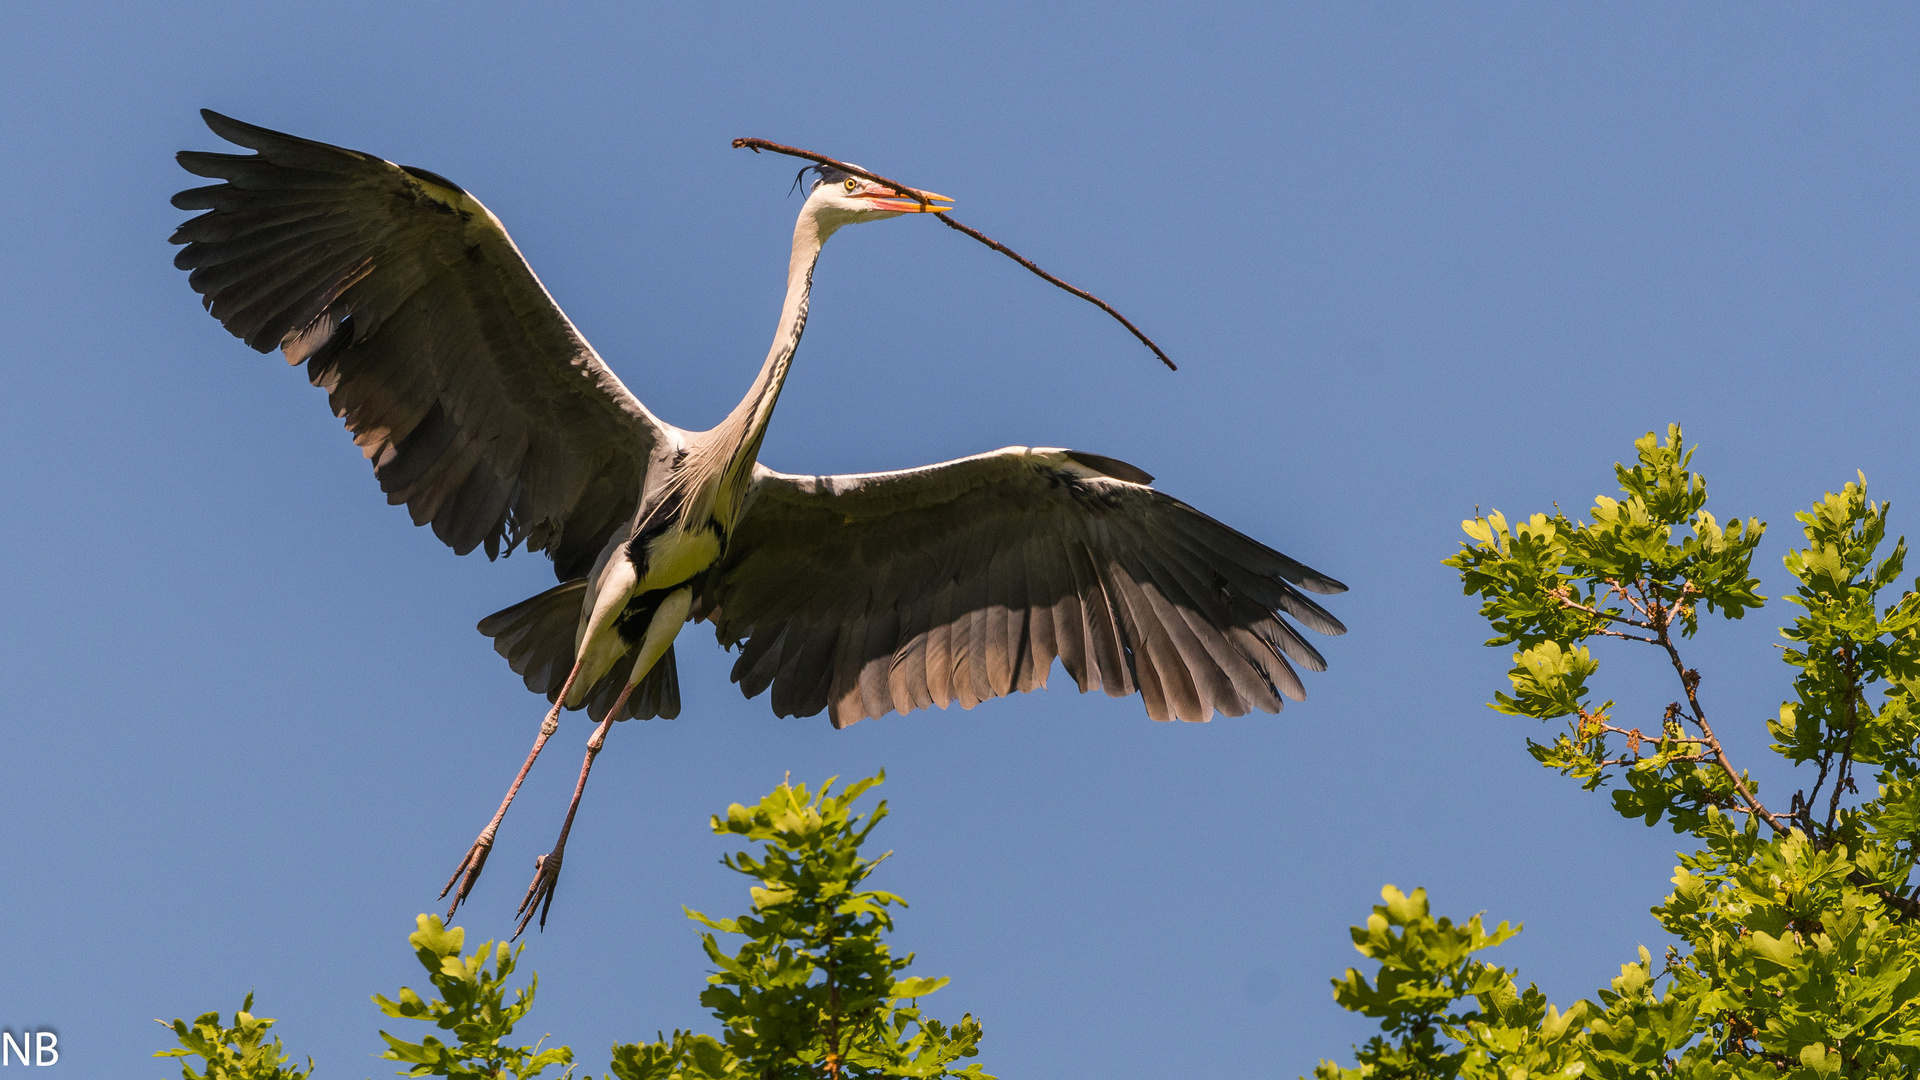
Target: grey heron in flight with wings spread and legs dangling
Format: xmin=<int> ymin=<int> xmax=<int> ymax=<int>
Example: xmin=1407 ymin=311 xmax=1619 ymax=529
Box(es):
xmin=173 ymin=110 xmax=1346 ymax=934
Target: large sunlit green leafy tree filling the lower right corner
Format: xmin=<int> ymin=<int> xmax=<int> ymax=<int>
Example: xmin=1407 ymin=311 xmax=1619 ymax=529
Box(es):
xmin=1317 ymin=427 xmax=1920 ymax=1080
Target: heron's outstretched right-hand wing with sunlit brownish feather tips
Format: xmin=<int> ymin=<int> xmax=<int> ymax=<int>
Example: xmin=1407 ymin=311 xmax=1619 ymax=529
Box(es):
xmin=695 ymin=446 xmax=1346 ymax=726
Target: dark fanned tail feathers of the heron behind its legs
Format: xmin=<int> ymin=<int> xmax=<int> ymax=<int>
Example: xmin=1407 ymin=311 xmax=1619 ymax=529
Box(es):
xmin=480 ymin=578 xmax=680 ymax=723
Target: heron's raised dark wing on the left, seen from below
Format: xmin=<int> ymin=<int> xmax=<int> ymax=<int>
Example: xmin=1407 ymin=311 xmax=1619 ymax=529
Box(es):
xmin=173 ymin=111 xmax=664 ymax=580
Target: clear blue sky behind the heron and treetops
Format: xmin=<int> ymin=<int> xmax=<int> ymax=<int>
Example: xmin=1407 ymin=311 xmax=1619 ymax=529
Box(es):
xmin=0 ymin=2 xmax=1920 ymax=1078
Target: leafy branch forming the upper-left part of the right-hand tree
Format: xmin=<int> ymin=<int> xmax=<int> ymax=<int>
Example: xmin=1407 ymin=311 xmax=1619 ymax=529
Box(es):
xmin=1446 ymin=427 xmax=1788 ymax=832
